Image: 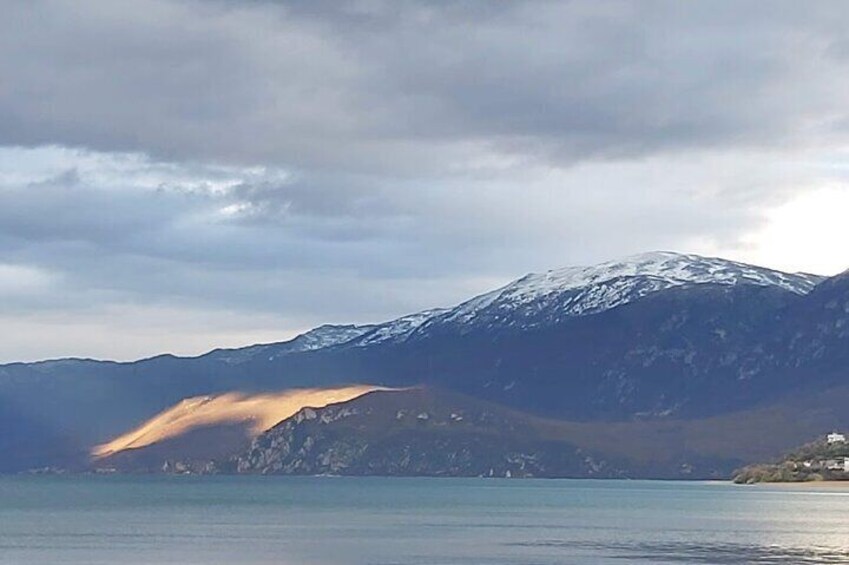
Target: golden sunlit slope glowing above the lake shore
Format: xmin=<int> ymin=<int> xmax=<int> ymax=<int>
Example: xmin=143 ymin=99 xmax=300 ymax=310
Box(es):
xmin=91 ymin=385 xmax=387 ymax=458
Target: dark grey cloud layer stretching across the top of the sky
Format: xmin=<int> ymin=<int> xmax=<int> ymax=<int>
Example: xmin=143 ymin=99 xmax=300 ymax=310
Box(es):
xmin=0 ymin=0 xmax=849 ymax=170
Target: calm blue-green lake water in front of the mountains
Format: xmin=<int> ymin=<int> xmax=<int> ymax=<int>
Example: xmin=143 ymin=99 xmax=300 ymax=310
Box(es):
xmin=0 ymin=477 xmax=849 ymax=565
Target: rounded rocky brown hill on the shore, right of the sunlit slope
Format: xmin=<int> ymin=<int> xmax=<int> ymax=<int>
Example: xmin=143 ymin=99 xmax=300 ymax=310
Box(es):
xmin=229 ymin=389 xmax=616 ymax=477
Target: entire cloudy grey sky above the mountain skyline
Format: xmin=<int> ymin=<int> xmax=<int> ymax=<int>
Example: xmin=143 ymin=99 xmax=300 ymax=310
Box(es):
xmin=0 ymin=0 xmax=849 ymax=362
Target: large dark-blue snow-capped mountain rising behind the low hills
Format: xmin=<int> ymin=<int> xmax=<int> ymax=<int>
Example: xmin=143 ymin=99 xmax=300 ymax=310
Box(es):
xmin=0 ymin=249 xmax=849 ymax=474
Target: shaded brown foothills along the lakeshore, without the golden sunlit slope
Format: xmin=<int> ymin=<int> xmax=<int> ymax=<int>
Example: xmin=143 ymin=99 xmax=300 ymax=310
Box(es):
xmin=93 ymin=387 xmax=849 ymax=479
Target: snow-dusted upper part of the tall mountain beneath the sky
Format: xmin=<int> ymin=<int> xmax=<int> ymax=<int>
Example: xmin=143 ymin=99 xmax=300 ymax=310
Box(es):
xmin=210 ymin=251 xmax=823 ymax=363
